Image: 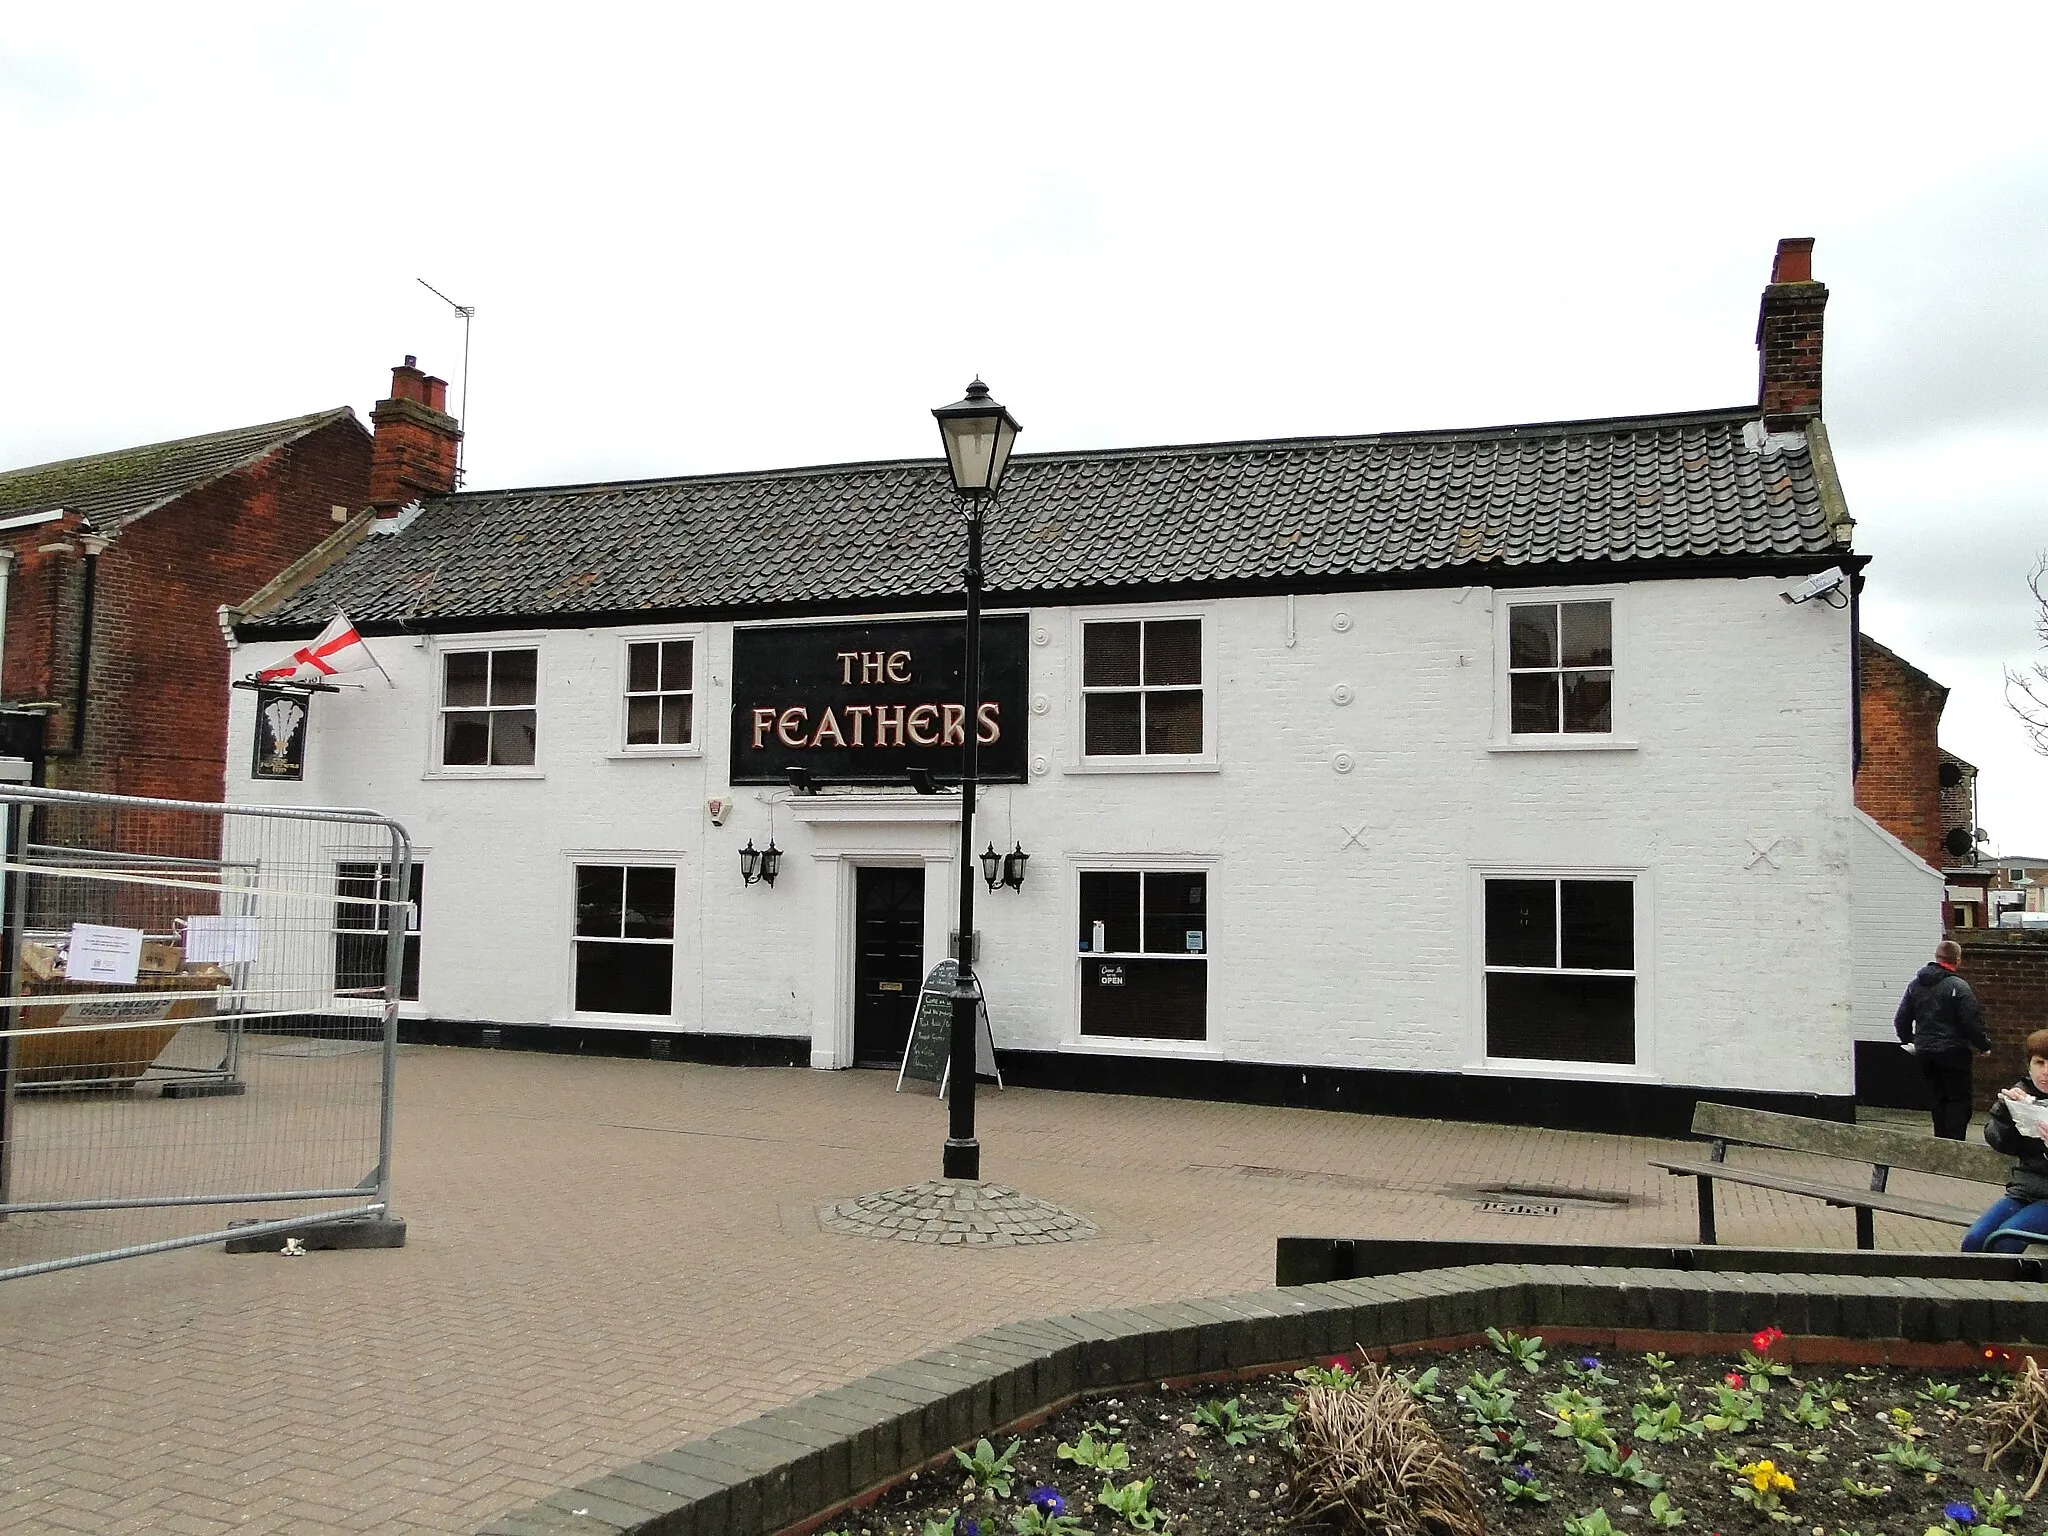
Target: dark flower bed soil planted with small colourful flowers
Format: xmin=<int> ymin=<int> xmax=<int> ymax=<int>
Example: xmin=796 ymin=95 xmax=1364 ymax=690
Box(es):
xmin=823 ymin=1346 xmax=2048 ymax=1536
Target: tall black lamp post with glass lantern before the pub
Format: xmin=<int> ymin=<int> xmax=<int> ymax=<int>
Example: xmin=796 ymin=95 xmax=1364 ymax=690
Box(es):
xmin=932 ymin=379 xmax=1018 ymax=1180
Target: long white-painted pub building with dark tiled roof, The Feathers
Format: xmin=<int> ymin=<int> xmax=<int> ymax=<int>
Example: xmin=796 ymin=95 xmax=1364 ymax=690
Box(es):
xmin=227 ymin=242 xmax=1939 ymax=1130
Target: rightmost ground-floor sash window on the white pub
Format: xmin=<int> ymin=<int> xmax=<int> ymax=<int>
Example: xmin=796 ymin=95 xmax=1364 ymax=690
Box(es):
xmin=1487 ymin=877 xmax=1636 ymax=1065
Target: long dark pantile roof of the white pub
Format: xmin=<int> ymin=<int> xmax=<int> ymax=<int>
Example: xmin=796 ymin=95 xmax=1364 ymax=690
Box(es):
xmin=246 ymin=408 xmax=1849 ymax=633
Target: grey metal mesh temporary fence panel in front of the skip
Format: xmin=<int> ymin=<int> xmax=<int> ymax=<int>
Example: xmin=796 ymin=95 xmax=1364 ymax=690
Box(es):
xmin=0 ymin=788 xmax=418 ymax=1280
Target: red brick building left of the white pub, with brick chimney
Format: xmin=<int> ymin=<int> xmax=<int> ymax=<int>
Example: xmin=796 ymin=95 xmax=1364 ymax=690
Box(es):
xmin=0 ymin=358 xmax=461 ymax=801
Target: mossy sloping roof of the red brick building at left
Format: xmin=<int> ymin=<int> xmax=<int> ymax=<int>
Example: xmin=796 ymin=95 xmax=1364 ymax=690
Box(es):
xmin=0 ymin=406 xmax=356 ymax=532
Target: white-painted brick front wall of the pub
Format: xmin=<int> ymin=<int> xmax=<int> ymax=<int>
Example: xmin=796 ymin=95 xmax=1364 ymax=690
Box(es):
xmin=227 ymin=580 xmax=1862 ymax=1094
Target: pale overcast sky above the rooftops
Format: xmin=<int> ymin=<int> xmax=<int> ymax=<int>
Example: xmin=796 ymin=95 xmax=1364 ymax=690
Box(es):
xmin=0 ymin=0 xmax=2048 ymax=856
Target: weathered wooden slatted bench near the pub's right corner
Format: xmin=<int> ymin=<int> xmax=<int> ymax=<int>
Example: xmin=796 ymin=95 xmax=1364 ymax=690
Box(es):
xmin=1649 ymin=1102 xmax=2013 ymax=1247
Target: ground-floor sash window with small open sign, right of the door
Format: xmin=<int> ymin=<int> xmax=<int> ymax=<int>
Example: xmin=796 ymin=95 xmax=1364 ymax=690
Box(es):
xmin=1081 ymin=870 xmax=1208 ymax=1040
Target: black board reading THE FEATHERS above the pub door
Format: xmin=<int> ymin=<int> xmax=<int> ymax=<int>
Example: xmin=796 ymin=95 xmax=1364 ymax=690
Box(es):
xmin=731 ymin=614 xmax=1030 ymax=784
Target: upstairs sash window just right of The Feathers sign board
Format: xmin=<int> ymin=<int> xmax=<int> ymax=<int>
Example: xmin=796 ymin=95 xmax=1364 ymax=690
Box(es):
xmin=1081 ymin=618 xmax=1204 ymax=758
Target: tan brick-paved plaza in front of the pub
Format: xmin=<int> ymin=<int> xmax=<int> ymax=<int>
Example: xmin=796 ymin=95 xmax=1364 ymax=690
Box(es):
xmin=0 ymin=1047 xmax=1970 ymax=1536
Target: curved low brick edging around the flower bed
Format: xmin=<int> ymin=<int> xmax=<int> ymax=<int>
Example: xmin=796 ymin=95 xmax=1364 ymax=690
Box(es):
xmin=483 ymin=1264 xmax=2048 ymax=1536
